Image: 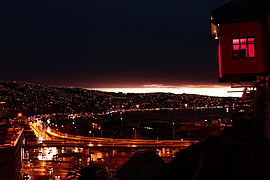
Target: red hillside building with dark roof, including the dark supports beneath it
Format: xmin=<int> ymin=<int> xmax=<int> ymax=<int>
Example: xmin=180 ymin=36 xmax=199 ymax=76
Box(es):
xmin=211 ymin=0 xmax=270 ymax=139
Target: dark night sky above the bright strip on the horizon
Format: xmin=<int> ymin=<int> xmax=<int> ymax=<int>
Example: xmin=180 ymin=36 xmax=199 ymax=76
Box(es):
xmin=0 ymin=0 xmax=228 ymax=88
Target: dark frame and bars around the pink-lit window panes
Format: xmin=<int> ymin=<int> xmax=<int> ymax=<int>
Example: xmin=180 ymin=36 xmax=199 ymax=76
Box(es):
xmin=231 ymin=36 xmax=257 ymax=59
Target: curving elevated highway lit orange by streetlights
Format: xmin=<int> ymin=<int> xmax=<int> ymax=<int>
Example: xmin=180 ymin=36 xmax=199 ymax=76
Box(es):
xmin=28 ymin=122 xmax=198 ymax=148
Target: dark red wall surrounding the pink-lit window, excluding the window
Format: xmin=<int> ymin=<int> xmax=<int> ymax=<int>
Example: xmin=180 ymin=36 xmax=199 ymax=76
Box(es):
xmin=219 ymin=21 xmax=266 ymax=76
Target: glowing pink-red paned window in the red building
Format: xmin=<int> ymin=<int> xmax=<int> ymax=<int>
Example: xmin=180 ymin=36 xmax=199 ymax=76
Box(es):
xmin=233 ymin=37 xmax=255 ymax=58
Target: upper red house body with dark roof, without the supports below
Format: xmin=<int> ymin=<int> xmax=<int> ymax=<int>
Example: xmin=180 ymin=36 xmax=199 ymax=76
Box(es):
xmin=211 ymin=0 xmax=270 ymax=82
